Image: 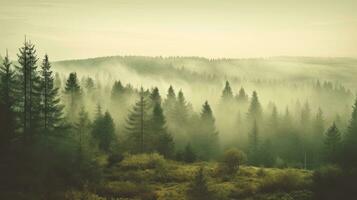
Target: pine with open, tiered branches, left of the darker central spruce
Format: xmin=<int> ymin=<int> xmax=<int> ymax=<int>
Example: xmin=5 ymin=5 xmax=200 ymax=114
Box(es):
xmin=126 ymin=88 xmax=150 ymax=153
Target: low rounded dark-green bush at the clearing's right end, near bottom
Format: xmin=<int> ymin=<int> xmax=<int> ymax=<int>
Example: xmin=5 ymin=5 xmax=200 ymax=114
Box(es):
xmin=259 ymin=170 xmax=309 ymax=193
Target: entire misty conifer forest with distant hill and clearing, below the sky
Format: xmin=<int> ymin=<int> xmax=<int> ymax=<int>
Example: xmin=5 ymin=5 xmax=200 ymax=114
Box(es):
xmin=0 ymin=40 xmax=357 ymax=200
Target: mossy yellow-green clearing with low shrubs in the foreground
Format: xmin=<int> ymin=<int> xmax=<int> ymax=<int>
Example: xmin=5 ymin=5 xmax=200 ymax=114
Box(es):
xmin=67 ymin=154 xmax=312 ymax=200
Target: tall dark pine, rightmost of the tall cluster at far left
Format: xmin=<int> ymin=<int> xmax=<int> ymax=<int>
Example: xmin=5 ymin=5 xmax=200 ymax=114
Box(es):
xmin=40 ymin=55 xmax=63 ymax=133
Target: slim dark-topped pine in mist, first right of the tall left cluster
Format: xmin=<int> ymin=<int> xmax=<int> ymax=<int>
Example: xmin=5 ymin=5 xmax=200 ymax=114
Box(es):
xmin=65 ymin=72 xmax=81 ymax=122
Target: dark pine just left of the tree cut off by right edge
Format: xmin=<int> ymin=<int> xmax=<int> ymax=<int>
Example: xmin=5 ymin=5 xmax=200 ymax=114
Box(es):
xmin=324 ymin=123 xmax=341 ymax=163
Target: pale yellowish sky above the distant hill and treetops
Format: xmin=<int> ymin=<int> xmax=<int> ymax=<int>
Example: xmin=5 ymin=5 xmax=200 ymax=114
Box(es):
xmin=0 ymin=0 xmax=357 ymax=60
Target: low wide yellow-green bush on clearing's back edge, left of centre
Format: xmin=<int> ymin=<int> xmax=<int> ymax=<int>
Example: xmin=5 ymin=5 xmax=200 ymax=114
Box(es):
xmin=120 ymin=153 xmax=166 ymax=170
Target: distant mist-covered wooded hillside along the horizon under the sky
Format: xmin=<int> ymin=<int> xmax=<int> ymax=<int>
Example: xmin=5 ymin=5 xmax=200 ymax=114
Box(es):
xmin=54 ymin=56 xmax=357 ymax=89
